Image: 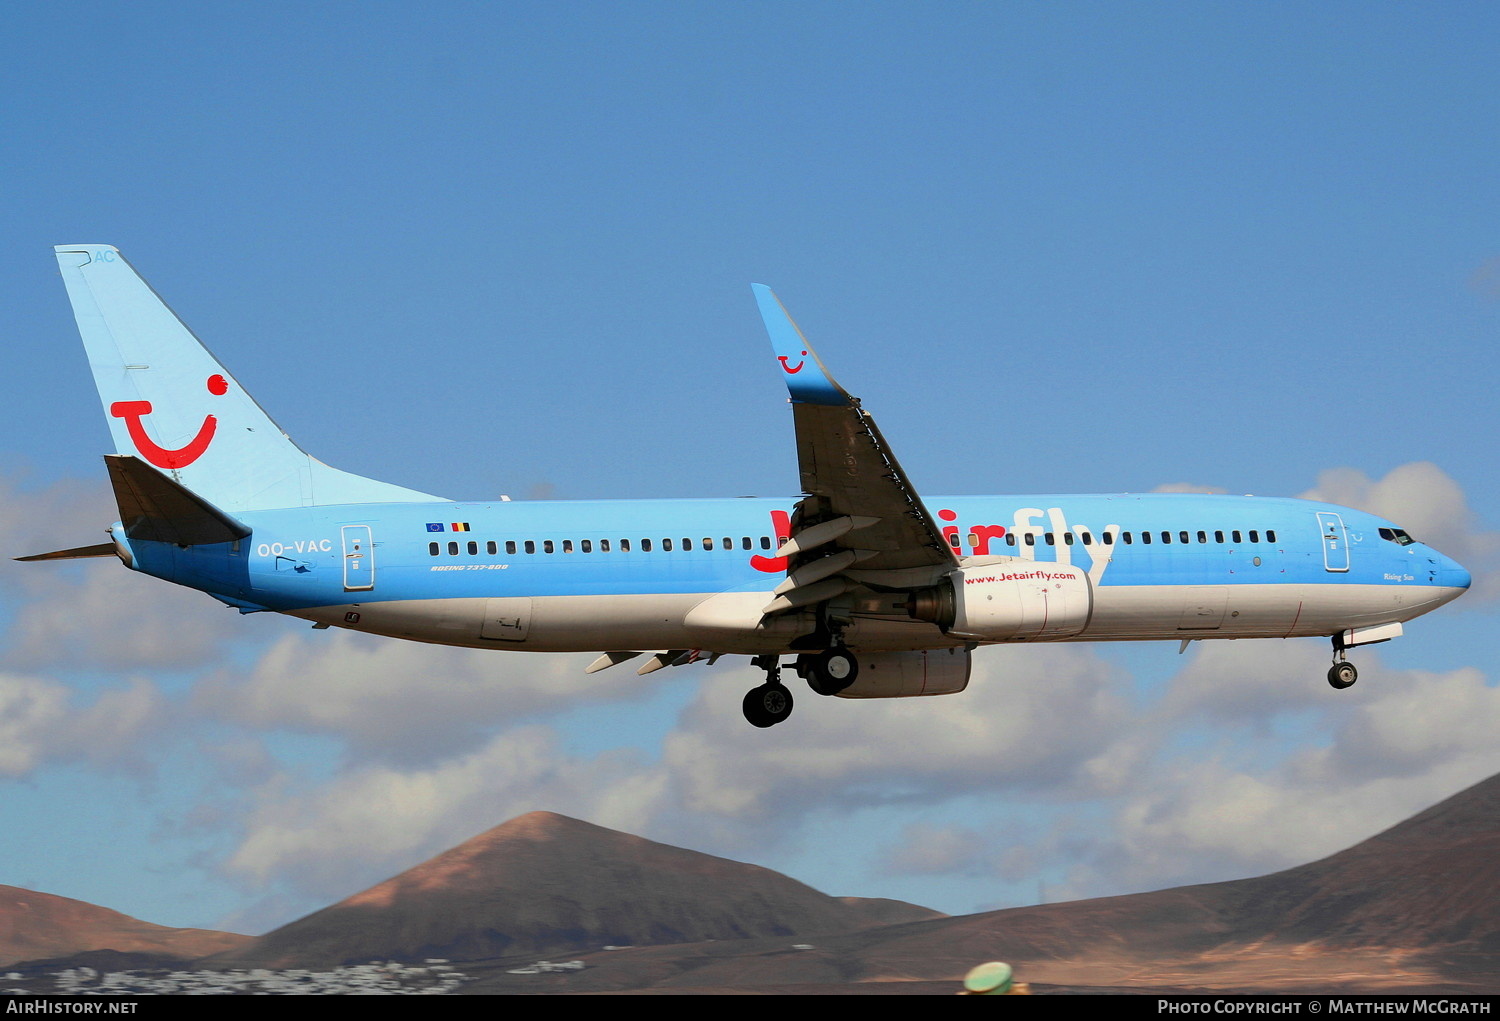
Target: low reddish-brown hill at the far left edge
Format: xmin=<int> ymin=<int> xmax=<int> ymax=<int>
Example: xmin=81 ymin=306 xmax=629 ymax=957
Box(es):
xmin=0 ymin=886 xmax=251 ymax=966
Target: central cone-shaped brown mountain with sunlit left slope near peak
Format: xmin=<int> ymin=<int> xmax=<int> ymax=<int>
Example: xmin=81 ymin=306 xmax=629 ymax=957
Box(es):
xmin=217 ymin=813 xmax=939 ymax=967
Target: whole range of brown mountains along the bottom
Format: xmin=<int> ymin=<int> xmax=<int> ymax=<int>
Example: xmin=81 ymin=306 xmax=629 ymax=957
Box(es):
xmin=14 ymin=777 xmax=1500 ymax=994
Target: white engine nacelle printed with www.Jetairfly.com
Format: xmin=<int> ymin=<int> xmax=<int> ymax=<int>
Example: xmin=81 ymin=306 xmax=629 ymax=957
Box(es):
xmin=908 ymin=558 xmax=1094 ymax=642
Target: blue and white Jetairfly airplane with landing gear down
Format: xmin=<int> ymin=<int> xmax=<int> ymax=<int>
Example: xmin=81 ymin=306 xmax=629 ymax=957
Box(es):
xmin=17 ymin=244 xmax=1470 ymax=727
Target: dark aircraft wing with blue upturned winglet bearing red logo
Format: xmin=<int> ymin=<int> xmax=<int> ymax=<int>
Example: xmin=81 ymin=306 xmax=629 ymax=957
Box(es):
xmin=752 ymin=283 xmax=959 ymax=613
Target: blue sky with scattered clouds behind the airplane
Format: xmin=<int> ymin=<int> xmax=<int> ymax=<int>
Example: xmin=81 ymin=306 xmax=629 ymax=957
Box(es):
xmin=0 ymin=3 xmax=1500 ymax=931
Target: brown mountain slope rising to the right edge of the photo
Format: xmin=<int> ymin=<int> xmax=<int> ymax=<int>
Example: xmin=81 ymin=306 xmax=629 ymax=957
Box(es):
xmin=738 ymin=775 xmax=1500 ymax=993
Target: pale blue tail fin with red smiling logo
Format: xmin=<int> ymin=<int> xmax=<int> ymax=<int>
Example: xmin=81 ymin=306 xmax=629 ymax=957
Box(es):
xmin=54 ymin=244 xmax=441 ymax=513
